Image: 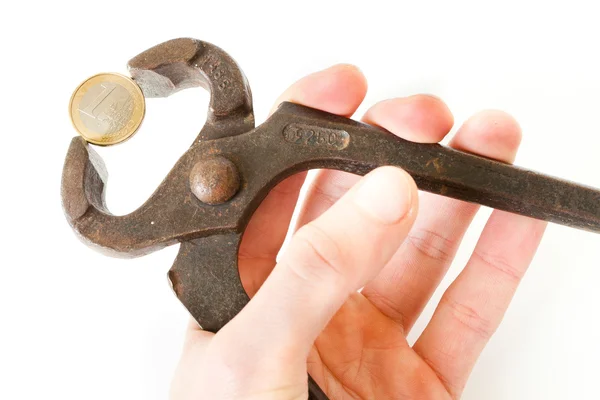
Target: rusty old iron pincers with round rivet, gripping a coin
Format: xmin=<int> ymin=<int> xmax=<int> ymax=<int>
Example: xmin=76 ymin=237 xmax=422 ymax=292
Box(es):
xmin=62 ymin=39 xmax=600 ymax=400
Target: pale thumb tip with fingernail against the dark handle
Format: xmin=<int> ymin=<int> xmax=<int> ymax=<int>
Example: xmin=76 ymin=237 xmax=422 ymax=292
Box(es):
xmin=354 ymin=167 xmax=413 ymax=224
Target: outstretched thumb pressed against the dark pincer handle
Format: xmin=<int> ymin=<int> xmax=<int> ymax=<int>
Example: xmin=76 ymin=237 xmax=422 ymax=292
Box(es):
xmin=217 ymin=167 xmax=418 ymax=360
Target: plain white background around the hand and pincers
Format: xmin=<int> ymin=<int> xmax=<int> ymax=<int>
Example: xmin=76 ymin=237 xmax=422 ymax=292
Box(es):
xmin=0 ymin=0 xmax=600 ymax=400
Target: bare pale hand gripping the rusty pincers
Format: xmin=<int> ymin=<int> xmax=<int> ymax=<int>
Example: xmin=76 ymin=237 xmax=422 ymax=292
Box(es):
xmin=171 ymin=65 xmax=546 ymax=400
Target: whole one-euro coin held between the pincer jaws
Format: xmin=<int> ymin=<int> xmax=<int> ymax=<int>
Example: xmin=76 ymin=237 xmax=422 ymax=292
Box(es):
xmin=69 ymin=72 xmax=146 ymax=146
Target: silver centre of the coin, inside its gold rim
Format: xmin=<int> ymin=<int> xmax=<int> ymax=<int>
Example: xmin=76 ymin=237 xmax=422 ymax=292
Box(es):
xmin=79 ymin=82 xmax=134 ymax=135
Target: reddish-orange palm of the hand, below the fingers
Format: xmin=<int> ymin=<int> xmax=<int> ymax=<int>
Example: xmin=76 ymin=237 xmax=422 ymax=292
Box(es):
xmin=309 ymin=293 xmax=450 ymax=400
